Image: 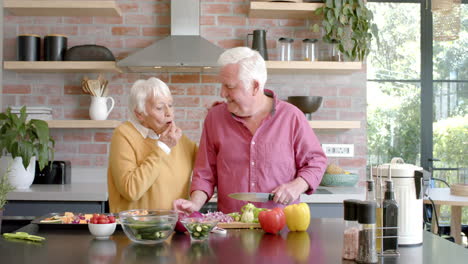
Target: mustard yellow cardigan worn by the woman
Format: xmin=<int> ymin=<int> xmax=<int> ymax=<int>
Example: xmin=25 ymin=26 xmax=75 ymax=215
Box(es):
xmin=107 ymin=122 xmax=197 ymax=213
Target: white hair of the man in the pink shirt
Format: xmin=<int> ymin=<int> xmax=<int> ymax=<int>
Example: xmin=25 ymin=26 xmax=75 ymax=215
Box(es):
xmin=218 ymin=47 xmax=267 ymax=91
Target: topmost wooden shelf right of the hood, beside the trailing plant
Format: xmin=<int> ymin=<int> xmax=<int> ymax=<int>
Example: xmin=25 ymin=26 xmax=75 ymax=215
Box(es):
xmin=249 ymin=2 xmax=323 ymax=19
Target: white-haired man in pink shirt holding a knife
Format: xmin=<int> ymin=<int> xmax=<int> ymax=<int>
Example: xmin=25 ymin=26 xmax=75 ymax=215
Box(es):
xmin=174 ymin=47 xmax=327 ymax=213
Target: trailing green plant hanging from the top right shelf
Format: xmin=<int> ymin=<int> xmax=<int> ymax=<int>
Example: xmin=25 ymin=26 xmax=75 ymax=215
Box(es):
xmin=313 ymin=0 xmax=377 ymax=61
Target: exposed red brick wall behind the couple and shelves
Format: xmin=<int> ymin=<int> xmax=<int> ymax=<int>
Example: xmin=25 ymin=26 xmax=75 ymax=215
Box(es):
xmin=2 ymin=0 xmax=367 ymax=177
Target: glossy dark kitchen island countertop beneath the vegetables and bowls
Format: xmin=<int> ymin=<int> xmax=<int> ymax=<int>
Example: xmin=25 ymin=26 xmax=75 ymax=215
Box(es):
xmin=0 ymin=218 xmax=468 ymax=264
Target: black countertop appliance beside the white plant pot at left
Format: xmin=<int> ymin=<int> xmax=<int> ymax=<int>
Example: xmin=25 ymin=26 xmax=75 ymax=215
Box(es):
xmin=33 ymin=160 xmax=71 ymax=184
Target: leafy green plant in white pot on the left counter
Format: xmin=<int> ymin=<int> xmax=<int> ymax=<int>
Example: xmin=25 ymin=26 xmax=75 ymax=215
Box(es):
xmin=0 ymin=106 xmax=55 ymax=189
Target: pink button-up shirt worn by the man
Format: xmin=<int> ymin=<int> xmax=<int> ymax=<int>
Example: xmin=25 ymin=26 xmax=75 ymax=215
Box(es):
xmin=191 ymin=90 xmax=327 ymax=213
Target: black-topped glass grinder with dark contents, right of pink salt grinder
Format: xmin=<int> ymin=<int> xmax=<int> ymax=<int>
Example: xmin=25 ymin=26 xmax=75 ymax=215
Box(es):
xmin=356 ymin=201 xmax=378 ymax=263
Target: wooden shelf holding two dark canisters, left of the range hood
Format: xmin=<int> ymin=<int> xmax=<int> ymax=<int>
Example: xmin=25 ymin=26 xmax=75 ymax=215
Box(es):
xmin=3 ymin=61 xmax=121 ymax=73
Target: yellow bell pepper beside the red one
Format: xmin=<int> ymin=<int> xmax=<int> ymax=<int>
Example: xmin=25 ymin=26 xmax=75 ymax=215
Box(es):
xmin=284 ymin=203 xmax=310 ymax=231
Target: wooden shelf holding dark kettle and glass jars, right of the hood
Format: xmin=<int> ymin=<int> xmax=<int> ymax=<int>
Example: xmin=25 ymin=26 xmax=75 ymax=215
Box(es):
xmin=266 ymin=61 xmax=362 ymax=74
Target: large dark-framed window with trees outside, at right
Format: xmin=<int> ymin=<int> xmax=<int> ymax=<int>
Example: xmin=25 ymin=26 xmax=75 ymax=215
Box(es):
xmin=367 ymin=0 xmax=468 ymax=224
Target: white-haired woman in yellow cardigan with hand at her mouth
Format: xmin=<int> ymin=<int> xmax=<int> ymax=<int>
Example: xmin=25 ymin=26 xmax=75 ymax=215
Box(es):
xmin=107 ymin=78 xmax=197 ymax=213
